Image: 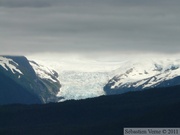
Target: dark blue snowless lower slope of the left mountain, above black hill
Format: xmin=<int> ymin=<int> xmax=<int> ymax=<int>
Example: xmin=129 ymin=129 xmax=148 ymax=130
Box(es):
xmin=0 ymin=70 xmax=41 ymax=104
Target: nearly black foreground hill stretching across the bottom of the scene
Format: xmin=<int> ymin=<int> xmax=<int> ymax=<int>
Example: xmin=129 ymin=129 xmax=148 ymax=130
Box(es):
xmin=0 ymin=86 xmax=180 ymax=135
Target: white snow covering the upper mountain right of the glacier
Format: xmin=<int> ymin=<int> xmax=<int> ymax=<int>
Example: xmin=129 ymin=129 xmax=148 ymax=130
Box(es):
xmin=111 ymin=58 xmax=180 ymax=89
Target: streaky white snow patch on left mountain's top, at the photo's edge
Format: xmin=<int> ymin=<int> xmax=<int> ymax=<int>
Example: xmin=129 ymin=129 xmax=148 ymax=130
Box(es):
xmin=0 ymin=56 xmax=23 ymax=75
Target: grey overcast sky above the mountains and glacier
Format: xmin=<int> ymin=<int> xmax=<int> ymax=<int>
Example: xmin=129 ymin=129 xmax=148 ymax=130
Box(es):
xmin=0 ymin=0 xmax=180 ymax=55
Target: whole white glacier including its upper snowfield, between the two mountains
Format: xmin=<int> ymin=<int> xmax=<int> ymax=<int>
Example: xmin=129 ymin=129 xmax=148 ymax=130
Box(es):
xmin=29 ymin=55 xmax=119 ymax=102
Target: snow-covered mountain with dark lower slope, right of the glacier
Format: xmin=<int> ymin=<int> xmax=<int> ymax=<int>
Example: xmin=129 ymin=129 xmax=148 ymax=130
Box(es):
xmin=104 ymin=58 xmax=180 ymax=94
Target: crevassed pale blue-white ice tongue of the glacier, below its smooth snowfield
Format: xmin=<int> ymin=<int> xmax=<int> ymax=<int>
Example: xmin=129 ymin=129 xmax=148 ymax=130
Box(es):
xmin=57 ymin=71 xmax=109 ymax=101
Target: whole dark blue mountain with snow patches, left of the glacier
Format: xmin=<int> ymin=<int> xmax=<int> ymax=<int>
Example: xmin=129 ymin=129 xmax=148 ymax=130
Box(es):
xmin=0 ymin=56 xmax=60 ymax=104
